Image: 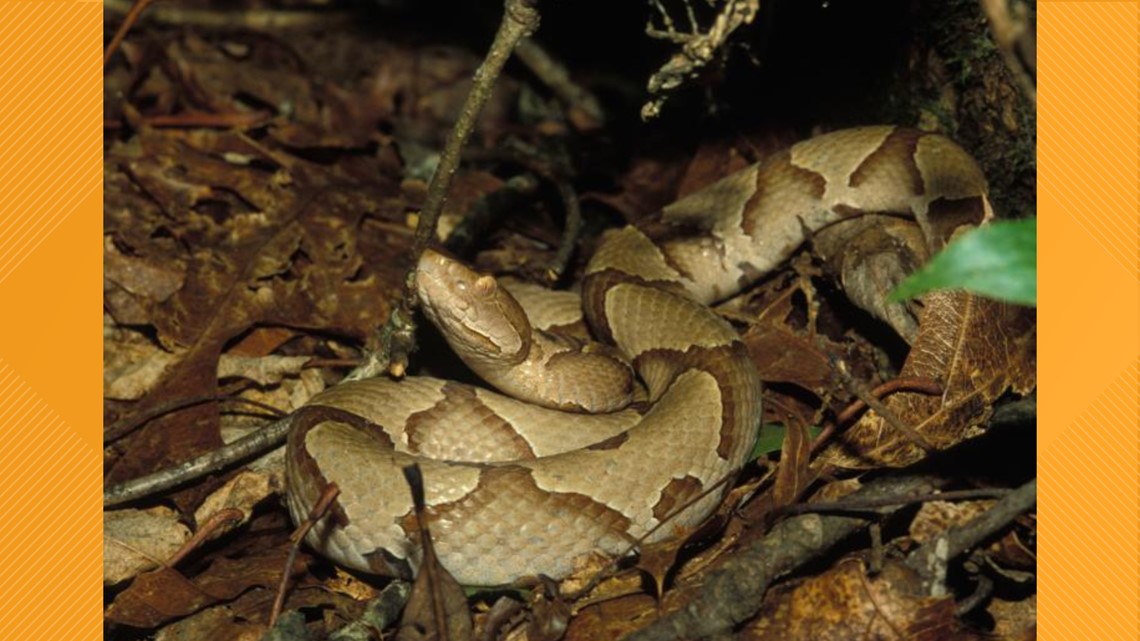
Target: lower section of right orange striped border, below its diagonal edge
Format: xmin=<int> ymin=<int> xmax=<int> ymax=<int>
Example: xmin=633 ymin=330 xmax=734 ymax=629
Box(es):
xmin=1037 ymin=363 xmax=1140 ymax=641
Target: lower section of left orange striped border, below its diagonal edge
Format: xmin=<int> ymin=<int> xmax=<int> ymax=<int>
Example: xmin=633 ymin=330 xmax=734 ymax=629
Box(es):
xmin=0 ymin=360 xmax=103 ymax=639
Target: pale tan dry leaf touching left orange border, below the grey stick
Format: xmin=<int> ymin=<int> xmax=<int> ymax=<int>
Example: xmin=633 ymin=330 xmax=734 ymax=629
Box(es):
xmin=103 ymin=506 xmax=190 ymax=585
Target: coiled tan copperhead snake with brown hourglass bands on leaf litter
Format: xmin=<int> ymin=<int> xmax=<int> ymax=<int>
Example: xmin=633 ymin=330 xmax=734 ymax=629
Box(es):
xmin=286 ymin=127 xmax=991 ymax=585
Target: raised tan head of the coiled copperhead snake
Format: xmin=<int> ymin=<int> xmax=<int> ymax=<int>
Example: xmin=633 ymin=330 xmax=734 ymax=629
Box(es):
xmin=416 ymin=250 xmax=531 ymax=366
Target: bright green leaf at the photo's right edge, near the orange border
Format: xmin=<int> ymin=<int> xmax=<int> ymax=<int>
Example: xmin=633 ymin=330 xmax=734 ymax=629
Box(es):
xmin=888 ymin=218 xmax=1037 ymax=306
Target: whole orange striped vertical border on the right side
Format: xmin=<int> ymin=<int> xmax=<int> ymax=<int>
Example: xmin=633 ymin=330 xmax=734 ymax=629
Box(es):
xmin=1037 ymin=0 xmax=1140 ymax=640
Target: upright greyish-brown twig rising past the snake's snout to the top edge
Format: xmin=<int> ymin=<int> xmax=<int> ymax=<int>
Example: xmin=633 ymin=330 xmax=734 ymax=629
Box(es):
xmin=347 ymin=0 xmax=539 ymax=380
